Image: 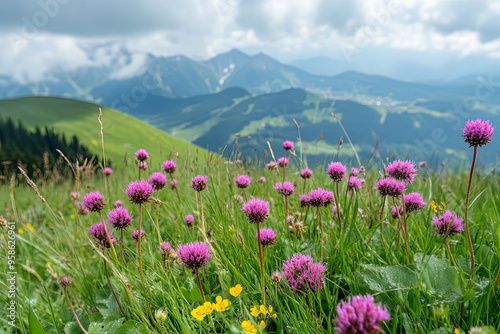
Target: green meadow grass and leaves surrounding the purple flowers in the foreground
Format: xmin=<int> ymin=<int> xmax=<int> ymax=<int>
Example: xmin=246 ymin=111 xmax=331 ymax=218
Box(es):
xmin=0 ymin=129 xmax=500 ymax=334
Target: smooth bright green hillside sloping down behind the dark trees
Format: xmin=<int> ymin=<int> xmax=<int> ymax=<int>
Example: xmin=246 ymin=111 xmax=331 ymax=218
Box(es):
xmin=0 ymin=97 xmax=205 ymax=161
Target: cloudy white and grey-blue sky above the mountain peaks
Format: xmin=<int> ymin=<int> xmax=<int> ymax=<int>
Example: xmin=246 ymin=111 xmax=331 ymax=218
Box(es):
xmin=0 ymin=0 xmax=500 ymax=80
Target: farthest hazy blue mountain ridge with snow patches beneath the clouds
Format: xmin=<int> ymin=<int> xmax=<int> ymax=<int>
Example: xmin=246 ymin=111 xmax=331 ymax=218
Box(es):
xmin=0 ymin=49 xmax=492 ymax=107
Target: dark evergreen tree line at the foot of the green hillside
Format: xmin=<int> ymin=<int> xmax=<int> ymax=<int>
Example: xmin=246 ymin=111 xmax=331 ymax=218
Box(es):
xmin=0 ymin=118 xmax=92 ymax=177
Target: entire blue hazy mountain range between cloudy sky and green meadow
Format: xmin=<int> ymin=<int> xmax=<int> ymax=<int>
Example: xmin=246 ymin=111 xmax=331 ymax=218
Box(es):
xmin=0 ymin=49 xmax=500 ymax=166
